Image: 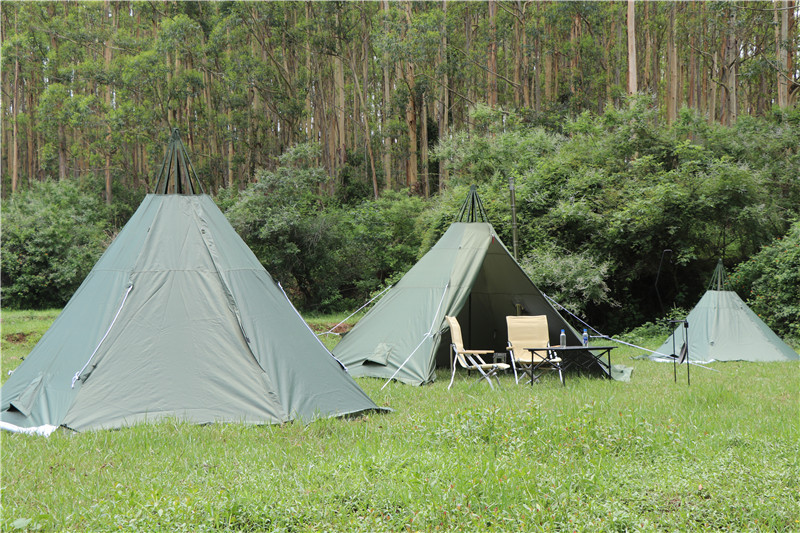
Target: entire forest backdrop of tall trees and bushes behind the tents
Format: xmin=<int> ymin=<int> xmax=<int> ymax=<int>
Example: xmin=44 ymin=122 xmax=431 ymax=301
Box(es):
xmin=0 ymin=0 xmax=800 ymax=337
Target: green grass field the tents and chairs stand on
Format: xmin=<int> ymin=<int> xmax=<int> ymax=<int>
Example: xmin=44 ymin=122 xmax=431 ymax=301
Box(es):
xmin=0 ymin=311 xmax=800 ymax=531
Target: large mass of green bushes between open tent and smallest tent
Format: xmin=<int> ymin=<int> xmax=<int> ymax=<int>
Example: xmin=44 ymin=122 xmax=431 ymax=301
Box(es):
xmin=436 ymin=97 xmax=800 ymax=331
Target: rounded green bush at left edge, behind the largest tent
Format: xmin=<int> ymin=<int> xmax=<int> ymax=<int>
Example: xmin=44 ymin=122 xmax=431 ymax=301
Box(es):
xmin=0 ymin=181 xmax=108 ymax=309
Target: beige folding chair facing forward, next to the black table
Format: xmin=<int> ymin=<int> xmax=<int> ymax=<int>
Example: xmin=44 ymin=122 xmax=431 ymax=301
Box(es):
xmin=506 ymin=315 xmax=564 ymax=385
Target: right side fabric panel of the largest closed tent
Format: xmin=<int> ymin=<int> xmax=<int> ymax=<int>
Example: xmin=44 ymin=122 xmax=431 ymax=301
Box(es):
xmin=193 ymin=191 xmax=377 ymax=420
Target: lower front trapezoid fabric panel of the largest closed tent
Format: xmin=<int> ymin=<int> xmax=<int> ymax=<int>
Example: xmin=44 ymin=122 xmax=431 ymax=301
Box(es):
xmin=64 ymin=271 xmax=287 ymax=431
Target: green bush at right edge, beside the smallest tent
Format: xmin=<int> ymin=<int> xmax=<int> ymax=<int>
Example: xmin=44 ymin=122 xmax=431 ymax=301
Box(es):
xmin=728 ymin=221 xmax=800 ymax=339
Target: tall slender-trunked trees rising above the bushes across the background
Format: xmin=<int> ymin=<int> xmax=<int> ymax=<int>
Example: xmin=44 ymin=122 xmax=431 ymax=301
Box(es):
xmin=0 ymin=0 xmax=800 ymax=200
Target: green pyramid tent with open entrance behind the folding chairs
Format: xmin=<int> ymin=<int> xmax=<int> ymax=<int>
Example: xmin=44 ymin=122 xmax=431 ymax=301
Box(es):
xmin=333 ymin=187 xmax=606 ymax=385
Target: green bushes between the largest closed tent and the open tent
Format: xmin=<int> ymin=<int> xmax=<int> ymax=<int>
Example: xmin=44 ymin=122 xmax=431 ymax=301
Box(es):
xmin=220 ymin=144 xmax=425 ymax=311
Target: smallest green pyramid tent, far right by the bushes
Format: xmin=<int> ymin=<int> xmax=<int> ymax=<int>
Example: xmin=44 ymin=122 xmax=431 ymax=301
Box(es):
xmin=657 ymin=261 xmax=800 ymax=363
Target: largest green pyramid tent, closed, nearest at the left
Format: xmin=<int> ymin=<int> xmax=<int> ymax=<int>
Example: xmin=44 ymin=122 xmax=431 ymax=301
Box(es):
xmin=0 ymin=132 xmax=377 ymax=434
